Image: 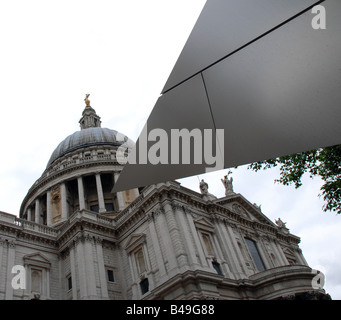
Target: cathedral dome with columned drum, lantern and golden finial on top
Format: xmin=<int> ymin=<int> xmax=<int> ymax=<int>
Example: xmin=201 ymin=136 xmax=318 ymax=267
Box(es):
xmin=20 ymin=94 xmax=139 ymax=226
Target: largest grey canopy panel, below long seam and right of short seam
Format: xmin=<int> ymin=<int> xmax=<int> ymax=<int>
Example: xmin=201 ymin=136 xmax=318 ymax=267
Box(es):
xmin=203 ymin=0 xmax=341 ymax=167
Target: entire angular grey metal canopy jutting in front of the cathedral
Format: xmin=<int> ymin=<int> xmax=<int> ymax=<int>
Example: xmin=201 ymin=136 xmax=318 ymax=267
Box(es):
xmin=114 ymin=0 xmax=341 ymax=191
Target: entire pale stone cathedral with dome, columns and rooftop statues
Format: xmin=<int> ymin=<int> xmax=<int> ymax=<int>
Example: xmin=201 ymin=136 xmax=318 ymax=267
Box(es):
xmin=0 ymin=98 xmax=327 ymax=300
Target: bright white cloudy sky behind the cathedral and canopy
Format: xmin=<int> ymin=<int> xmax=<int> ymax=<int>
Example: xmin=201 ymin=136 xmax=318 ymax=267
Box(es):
xmin=0 ymin=0 xmax=341 ymax=299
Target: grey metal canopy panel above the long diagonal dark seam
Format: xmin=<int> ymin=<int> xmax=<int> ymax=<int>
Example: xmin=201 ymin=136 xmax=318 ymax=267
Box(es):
xmin=162 ymin=0 xmax=318 ymax=93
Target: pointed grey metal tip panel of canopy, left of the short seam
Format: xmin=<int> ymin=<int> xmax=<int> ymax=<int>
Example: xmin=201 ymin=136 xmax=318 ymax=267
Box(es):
xmin=113 ymin=75 xmax=215 ymax=192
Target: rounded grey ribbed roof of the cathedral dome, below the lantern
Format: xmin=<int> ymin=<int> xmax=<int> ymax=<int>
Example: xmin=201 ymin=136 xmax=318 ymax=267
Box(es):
xmin=47 ymin=127 xmax=134 ymax=167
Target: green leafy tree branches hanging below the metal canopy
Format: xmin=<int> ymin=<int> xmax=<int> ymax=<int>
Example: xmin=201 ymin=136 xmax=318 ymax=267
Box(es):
xmin=248 ymin=145 xmax=341 ymax=214
